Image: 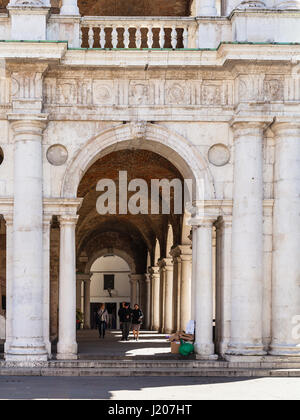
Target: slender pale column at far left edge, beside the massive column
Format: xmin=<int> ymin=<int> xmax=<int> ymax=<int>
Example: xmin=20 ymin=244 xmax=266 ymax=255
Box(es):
xmin=4 ymin=214 xmax=14 ymax=354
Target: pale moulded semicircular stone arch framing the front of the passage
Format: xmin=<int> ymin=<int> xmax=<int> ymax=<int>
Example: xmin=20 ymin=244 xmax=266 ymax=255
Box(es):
xmin=61 ymin=123 xmax=215 ymax=200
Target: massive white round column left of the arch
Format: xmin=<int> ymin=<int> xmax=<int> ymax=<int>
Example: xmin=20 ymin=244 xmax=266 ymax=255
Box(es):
xmin=6 ymin=114 xmax=48 ymax=362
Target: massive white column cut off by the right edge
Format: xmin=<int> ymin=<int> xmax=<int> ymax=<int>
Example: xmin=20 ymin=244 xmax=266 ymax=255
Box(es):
xmin=270 ymin=121 xmax=300 ymax=356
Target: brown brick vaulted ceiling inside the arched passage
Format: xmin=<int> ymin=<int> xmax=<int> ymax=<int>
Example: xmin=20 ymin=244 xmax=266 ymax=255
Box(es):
xmin=77 ymin=149 xmax=182 ymax=273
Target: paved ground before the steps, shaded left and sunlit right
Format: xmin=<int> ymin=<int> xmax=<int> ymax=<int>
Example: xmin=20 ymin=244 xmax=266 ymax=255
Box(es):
xmin=0 ymin=377 xmax=300 ymax=401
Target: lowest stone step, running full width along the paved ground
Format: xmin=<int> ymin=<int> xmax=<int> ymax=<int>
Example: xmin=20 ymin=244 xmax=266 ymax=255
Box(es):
xmin=0 ymin=367 xmax=300 ymax=378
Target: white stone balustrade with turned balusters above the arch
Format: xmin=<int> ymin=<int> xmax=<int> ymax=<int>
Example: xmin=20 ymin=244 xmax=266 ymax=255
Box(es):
xmin=80 ymin=17 xmax=197 ymax=49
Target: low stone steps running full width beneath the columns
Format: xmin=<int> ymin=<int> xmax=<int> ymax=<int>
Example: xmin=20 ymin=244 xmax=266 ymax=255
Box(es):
xmin=0 ymin=359 xmax=300 ymax=377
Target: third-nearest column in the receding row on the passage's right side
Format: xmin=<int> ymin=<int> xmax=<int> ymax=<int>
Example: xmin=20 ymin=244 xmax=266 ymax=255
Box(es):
xmin=163 ymin=258 xmax=174 ymax=334
